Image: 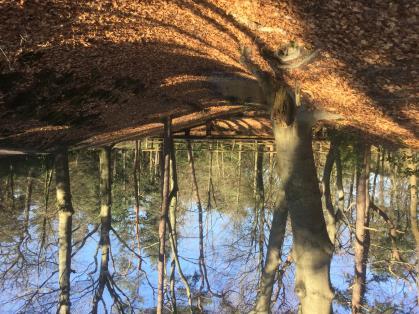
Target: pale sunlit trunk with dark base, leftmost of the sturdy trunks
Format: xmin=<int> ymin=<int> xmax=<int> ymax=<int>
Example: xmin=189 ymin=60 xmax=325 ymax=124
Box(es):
xmin=55 ymin=149 xmax=74 ymax=314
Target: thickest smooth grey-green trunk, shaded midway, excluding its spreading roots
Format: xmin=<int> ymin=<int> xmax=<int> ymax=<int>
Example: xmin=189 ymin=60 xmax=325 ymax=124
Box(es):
xmin=258 ymin=88 xmax=333 ymax=314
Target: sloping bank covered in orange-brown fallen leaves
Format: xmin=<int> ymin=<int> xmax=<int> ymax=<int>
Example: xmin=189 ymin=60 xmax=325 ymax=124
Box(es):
xmin=0 ymin=0 xmax=419 ymax=149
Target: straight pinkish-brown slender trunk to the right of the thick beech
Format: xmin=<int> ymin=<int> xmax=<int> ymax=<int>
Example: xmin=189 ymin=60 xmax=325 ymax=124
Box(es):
xmin=352 ymin=144 xmax=371 ymax=313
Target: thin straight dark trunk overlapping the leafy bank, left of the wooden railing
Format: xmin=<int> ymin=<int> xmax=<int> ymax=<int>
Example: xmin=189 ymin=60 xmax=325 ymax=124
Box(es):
xmin=157 ymin=117 xmax=172 ymax=314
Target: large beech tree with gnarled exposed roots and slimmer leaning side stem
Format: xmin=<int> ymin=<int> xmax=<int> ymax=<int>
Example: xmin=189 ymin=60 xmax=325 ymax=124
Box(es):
xmin=213 ymin=44 xmax=339 ymax=313
